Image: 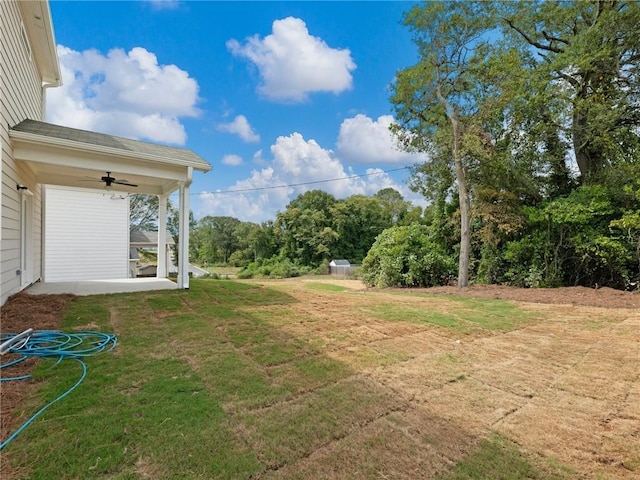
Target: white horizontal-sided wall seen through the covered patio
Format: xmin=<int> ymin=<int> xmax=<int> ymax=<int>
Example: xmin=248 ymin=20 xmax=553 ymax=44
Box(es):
xmin=44 ymin=185 xmax=129 ymax=282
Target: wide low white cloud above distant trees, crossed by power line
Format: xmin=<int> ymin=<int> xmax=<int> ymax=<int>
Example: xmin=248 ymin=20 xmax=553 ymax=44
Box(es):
xmin=195 ymin=133 xmax=411 ymax=222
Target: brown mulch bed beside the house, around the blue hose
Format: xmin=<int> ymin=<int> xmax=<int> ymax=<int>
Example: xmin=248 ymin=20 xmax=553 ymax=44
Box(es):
xmin=0 ymin=293 xmax=74 ymax=454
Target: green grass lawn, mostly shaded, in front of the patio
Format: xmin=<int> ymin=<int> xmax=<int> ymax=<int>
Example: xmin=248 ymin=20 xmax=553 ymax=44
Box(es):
xmin=3 ymin=279 xmax=568 ymax=479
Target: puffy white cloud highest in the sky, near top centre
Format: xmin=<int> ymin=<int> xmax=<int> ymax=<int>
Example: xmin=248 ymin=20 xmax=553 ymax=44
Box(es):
xmin=227 ymin=17 xmax=356 ymax=102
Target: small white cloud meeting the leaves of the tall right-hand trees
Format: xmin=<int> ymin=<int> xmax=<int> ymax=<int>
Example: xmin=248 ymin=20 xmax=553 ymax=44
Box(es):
xmin=336 ymin=114 xmax=425 ymax=165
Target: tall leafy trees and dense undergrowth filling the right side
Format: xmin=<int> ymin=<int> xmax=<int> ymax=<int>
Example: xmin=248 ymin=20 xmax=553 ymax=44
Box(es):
xmin=380 ymin=0 xmax=640 ymax=288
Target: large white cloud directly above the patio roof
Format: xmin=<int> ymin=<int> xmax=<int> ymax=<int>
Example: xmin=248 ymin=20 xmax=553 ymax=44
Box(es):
xmin=47 ymin=45 xmax=199 ymax=145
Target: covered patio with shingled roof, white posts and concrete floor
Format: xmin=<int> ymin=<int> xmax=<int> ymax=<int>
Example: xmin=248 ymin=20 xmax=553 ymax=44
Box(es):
xmin=9 ymin=120 xmax=211 ymax=295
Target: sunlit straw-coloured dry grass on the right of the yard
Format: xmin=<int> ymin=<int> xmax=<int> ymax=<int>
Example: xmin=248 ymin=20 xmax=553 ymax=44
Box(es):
xmin=242 ymin=282 xmax=640 ymax=479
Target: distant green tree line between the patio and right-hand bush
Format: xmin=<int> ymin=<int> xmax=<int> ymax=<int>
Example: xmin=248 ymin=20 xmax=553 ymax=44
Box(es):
xmin=190 ymin=188 xmax=422 ymax=275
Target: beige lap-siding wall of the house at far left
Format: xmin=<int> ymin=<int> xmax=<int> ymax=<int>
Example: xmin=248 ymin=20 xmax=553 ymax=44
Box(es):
xmin=0 ymin=0 xmax=44 ymax=305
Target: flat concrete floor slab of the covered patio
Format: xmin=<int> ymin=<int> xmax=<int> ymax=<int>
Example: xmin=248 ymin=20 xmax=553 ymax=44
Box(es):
xmin=24 ymin=278 xmax=178 ymax=295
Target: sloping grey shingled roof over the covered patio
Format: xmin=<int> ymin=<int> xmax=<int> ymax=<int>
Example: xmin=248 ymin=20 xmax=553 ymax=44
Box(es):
xmin=11 ymin=119 xmax=211 ymax=172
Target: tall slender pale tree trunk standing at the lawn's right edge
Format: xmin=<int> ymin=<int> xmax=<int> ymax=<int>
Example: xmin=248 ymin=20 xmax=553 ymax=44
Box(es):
xmin=451 ymin=109 xmax=471 ymax=288
